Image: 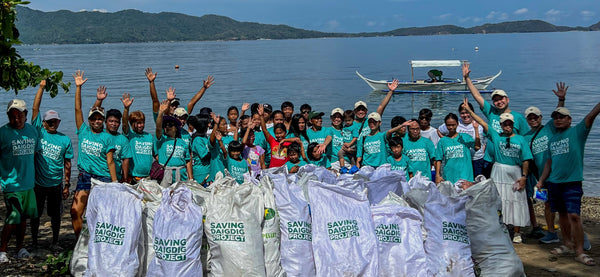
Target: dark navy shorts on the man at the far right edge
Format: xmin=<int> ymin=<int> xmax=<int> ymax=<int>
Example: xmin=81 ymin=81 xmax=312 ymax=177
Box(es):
xmin=545 ymin=181 xmax=583 ymax=215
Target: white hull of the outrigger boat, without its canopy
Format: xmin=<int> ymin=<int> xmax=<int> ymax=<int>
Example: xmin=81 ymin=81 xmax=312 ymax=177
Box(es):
xmin=356 ymin=71 xmax=502 ymax=93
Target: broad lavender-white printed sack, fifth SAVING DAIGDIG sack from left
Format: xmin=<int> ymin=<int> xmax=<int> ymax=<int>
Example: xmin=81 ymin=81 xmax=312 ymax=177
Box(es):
xmin=308 ymin=178 xmax=378 ymax=276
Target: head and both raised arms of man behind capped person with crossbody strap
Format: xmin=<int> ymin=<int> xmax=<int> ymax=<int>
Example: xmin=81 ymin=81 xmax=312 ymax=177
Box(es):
xmin=146 ymin=67 xmax=215 ymax=122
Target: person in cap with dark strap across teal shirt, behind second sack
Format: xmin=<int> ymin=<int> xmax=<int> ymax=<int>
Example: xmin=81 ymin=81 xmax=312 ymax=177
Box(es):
xmin=156 ymin=100 xmax=193 ymax=187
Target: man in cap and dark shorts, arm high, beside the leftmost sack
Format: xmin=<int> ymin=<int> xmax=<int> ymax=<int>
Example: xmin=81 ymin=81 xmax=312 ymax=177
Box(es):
xmin=71 ymin=70 xmax=118 ymax=237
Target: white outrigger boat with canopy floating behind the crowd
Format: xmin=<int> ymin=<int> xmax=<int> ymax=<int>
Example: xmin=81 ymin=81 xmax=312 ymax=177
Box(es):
xmin=356 ymin=60 xmax=502 ymax=93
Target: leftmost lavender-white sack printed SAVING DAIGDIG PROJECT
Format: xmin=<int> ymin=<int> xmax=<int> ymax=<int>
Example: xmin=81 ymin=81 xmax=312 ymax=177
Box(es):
xmin=85 ymin=183 xmax=142 ymax=276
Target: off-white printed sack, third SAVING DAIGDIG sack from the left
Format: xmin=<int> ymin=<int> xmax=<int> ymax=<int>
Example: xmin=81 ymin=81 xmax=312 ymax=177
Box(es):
xmin=205 ymin=177 xmax=266 ymax=276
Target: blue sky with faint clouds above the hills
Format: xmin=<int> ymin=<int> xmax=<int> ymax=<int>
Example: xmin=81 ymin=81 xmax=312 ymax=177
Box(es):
xmin=27 ymin=0 xmax=600 ymax=33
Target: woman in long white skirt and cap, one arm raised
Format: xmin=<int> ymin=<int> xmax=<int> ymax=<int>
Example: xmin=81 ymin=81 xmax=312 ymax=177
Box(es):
xmin=463 ymin=98 xmax=533 ymax=243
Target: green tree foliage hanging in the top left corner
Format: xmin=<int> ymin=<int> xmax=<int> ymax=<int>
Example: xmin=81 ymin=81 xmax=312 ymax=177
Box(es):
xmin=0 ymin=0 xmax=71 ymax=97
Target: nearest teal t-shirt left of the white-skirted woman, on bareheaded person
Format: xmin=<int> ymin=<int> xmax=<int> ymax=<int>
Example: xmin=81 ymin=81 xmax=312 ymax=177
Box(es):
xmin=435 ymin=133 xmax=475 ymax=183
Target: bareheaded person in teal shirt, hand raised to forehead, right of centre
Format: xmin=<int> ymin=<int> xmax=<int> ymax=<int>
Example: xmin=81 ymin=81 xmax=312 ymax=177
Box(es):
xmin=398 ymin=120 xmax=436 ymax=179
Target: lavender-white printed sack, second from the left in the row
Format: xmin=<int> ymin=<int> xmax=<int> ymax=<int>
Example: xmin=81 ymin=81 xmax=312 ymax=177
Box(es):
xmin=147 ymin=186 xmax=203 ymax=276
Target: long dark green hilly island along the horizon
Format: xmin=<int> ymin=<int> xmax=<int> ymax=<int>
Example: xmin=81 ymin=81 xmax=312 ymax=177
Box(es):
xmin=16 ymin=6 xmax=600 ymax=44
